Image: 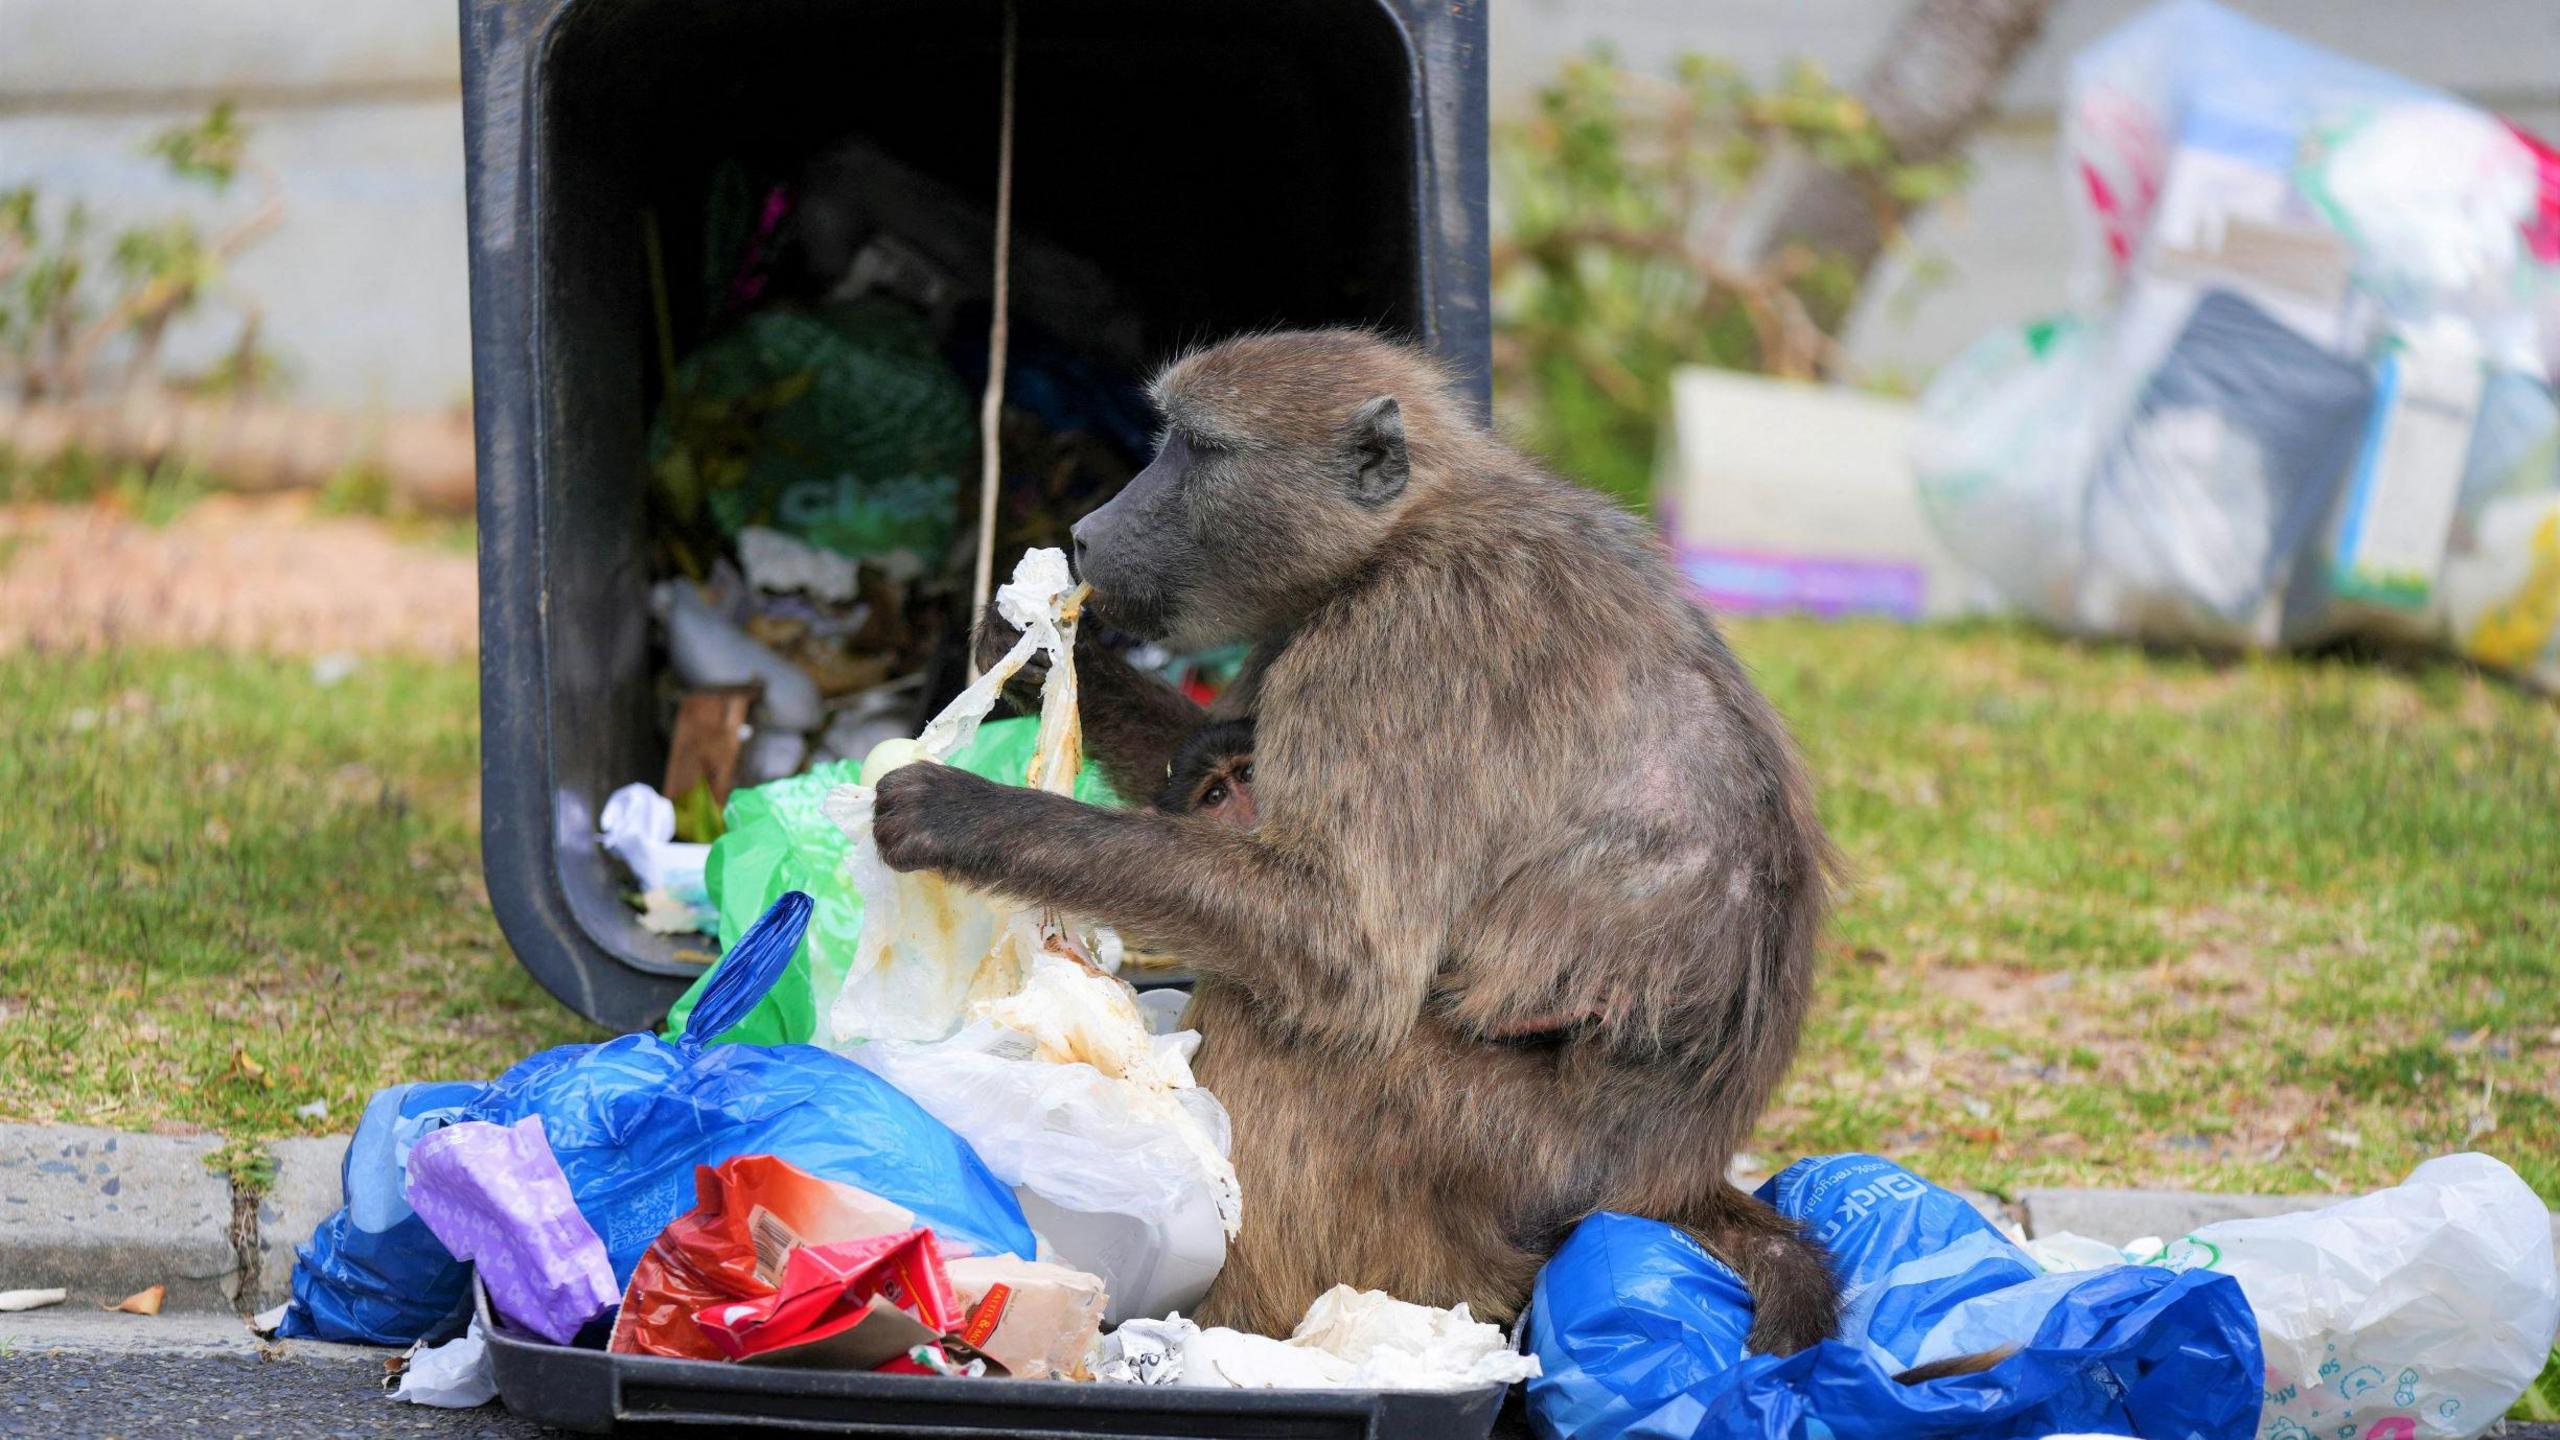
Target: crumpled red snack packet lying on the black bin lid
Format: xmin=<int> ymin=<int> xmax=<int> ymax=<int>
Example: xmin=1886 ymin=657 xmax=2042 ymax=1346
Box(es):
xmin=609 ymin=1156 xmax=916 ymax=1361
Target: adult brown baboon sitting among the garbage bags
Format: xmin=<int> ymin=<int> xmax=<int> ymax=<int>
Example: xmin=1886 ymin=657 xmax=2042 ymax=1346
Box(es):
xmin=873 ymin=331 xmax=1838 ymax=1353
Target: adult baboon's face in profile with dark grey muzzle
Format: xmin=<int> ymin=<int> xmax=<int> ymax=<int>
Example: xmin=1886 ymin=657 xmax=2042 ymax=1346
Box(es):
xmin=1075 ymin=395 xmax=1411 ymax=648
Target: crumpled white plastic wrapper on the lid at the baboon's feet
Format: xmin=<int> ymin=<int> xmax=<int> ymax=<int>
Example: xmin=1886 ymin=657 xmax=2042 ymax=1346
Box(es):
xmin=1093 ymin=1286 xmax=1539 ymax=1389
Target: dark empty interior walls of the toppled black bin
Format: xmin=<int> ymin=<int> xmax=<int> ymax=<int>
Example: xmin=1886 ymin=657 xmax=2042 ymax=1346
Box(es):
xmin=527 ymin=0 xmax=1423 ymax=974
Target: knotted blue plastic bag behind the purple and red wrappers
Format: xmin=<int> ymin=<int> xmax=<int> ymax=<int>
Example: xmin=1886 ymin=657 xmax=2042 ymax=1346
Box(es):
xmin=282 ymin=892 xmax=1034 ymax=1345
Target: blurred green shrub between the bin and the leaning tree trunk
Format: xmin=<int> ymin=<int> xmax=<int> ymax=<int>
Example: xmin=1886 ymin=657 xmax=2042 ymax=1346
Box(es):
xmin=1492 ymin=51 xmax=1964 ymax=510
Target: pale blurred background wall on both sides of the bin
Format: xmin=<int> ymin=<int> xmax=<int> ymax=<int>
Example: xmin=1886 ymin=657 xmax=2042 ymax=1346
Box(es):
xmin=0 ymin=0 xmax=2560 ymax=407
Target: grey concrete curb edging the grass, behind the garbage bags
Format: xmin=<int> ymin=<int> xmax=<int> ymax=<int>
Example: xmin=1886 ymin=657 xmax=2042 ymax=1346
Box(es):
xmin=0 ymin=1125 xmax=2560 ymax=1325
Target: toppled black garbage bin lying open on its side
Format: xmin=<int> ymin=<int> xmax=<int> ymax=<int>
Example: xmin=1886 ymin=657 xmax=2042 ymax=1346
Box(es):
xmin=461 ymin=0 xmax=1487 ymax=1027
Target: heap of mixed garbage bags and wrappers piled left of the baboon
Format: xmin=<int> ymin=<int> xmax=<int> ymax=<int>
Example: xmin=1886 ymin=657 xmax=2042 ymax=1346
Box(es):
xmin=266 ymin=551 xmax=1536 ymax=1404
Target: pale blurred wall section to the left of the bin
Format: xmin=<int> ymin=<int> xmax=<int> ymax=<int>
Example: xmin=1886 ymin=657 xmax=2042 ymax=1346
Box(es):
xmin=0 ymin=0 xmax=471 ymax=407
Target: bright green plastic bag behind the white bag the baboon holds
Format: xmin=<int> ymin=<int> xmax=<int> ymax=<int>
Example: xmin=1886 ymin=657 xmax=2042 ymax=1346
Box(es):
xmin=666 ymin=715 xmax=1121 ymax=1045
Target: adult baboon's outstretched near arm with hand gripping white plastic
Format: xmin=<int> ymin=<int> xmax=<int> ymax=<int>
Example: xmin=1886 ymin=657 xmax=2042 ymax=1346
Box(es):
xmin=873 ymin=764 xmax=1446 ymax=1051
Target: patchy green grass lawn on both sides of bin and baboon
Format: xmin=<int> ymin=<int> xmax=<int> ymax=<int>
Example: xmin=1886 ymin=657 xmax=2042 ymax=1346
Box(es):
xmin=0 ymin=623 xmax=2560 ymax=1199
